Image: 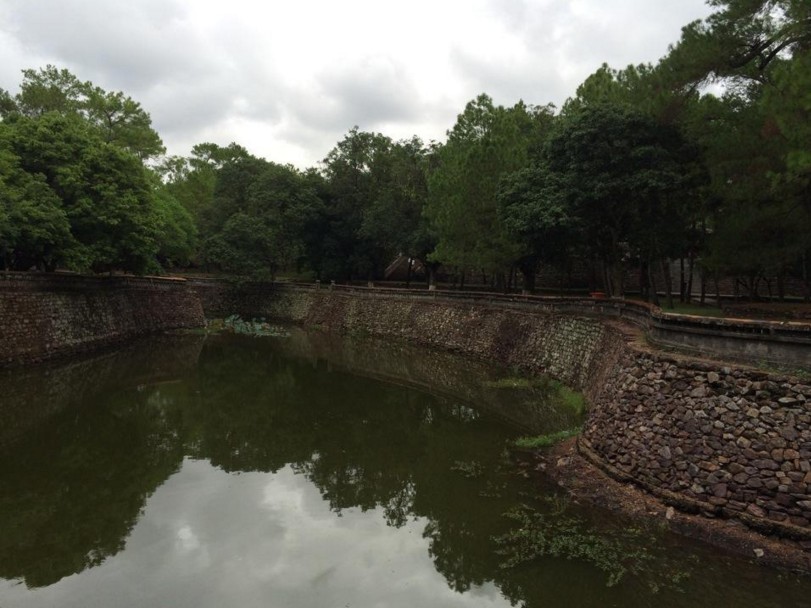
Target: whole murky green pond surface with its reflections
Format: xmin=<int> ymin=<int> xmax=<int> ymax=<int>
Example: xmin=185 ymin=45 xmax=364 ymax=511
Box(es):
xmin=0 ymin=329 xmax=811 ymax=608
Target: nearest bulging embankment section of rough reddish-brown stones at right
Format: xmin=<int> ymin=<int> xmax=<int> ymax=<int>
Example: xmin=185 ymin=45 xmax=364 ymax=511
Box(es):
xmin=582 ymin=348 xmax=811 ymax=538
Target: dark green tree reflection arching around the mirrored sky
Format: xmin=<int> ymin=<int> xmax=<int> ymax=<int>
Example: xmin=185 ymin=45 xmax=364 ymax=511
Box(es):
xmin=0 ymin=336 xmax=580 ymax=604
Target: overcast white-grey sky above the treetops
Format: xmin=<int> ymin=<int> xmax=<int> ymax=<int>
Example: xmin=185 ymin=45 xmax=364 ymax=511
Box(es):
xmin=0 ymin=0 xmax=709 ymax=168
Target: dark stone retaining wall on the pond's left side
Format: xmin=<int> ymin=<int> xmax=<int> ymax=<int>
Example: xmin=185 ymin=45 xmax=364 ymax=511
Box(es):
xmin=0 ymin=273 xmax=205 ymax=365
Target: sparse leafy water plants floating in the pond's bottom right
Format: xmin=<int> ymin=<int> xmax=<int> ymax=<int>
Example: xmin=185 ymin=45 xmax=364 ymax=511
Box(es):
xmin=493 ymin=503 xmax=690 ymax=592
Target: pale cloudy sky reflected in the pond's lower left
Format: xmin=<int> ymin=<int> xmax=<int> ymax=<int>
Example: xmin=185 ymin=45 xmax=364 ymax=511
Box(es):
xmin=0 ymin=460 xmax=509 ymax=608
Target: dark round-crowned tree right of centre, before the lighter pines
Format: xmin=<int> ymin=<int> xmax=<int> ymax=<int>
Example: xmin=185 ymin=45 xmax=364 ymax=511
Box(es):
xmin=542 ymin=104 xmax=696 ymax=296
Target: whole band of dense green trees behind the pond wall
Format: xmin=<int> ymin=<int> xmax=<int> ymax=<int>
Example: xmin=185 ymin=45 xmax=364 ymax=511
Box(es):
xmin=0 ymin=0 xmax=811 ymax=300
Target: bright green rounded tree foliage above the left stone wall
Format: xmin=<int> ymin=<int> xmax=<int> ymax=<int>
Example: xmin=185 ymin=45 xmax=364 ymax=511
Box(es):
xmin=2 ymin=112 xmax=162 ymax=272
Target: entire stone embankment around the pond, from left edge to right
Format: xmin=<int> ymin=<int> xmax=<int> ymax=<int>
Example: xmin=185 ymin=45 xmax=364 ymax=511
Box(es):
xmin=0 ymin=273 xmax=811 ymax=540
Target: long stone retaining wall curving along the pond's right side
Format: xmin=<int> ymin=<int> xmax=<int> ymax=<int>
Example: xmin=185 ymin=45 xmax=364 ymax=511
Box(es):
xmin=232 ymin=289 xmax=811 ymax=539
